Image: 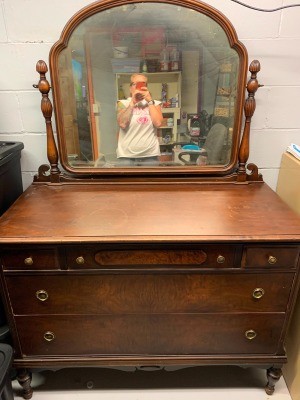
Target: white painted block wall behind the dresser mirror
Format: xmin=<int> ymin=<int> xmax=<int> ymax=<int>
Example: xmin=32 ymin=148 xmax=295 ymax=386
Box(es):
xmin=0 ymin=0 xmax=300 ymax=190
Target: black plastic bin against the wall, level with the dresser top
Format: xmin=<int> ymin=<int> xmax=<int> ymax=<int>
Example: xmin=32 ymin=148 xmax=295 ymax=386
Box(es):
xmin=0 ymin=141 xmax=24 ymax=215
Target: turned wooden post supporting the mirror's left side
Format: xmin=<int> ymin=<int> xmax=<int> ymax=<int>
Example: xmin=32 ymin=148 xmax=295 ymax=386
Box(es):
xmin=34 ymin=60 xmax=60 ymax=182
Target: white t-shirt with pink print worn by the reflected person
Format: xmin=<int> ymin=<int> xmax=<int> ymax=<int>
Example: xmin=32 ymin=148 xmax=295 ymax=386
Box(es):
xmin=117 ymin=97 xmax=161 ymax=158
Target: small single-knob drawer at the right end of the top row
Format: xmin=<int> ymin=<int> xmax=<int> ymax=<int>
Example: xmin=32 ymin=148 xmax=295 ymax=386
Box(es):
xmin=244 ymin=246 xmax=299 ymax=268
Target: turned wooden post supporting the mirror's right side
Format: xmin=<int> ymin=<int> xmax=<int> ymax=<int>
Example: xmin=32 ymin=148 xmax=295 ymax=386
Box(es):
xmin=237 ymin=60 xmax=262 ymax=182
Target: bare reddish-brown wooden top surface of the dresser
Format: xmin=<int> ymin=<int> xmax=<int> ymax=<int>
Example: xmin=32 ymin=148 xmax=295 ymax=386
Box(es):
xmin=0 ymin=183 xmax=300 ymax=243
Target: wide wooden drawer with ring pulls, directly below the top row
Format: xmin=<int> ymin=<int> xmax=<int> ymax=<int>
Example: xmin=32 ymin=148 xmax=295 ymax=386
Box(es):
xmin=6 ymin=272 xmax=294 ymax=315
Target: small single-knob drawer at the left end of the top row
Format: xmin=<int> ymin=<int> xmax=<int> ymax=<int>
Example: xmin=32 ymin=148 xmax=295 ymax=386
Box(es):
xmin=1 ymin=247 xmax=59 ymax=270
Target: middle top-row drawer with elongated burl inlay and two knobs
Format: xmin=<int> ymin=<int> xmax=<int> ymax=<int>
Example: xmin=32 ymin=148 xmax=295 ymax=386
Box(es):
xmin=67 ymin=244 xmax=242 ymax=269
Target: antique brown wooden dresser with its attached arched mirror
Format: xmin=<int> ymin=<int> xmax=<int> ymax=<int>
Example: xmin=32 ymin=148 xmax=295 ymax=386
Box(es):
xmin=0 ymin=0 xmax=300 ymax=399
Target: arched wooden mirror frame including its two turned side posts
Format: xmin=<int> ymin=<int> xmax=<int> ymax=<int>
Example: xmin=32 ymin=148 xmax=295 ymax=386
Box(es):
xmin=37 ymin=0 xmax=261 ymax=181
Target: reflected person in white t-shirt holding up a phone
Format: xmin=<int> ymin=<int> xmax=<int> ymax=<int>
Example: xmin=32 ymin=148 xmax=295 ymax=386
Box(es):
xmin=117 ymin=74 xmax=163 ymax=165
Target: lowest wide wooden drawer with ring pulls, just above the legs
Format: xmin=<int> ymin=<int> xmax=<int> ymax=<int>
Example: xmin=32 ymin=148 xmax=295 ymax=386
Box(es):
xmin=16 ymin=313 xmax=285 ymax=356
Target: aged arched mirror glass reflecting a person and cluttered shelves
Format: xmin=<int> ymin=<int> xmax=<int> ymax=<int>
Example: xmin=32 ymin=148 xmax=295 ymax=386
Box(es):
xmin=56 ymin=3 xmax=240 ymax=169
